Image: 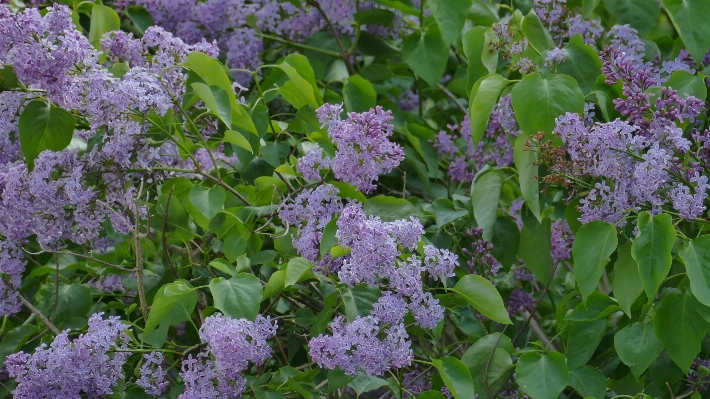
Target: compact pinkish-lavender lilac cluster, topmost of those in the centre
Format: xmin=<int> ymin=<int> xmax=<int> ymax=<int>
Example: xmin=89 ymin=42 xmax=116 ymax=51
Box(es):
xmin=299 ymin=104 xmax=404 ymax=193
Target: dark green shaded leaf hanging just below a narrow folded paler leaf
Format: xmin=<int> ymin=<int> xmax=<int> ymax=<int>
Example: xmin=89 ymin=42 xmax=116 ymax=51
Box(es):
xmin=518 ymin=218 xmax=553 ymax=283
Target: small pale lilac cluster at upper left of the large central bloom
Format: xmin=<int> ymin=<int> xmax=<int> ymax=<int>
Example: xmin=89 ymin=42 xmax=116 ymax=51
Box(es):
xmin=279 ymin=184 xmax=343 ymax=262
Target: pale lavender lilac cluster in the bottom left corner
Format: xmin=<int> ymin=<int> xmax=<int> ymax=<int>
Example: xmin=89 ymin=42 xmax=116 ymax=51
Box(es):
xmin=5 ymin=313 xmax=129 ymax=399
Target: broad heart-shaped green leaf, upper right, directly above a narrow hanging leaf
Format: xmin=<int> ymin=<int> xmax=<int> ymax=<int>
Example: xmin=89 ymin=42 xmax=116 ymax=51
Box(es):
xmin=516 ymin=73 xmax=584 ymax=140
